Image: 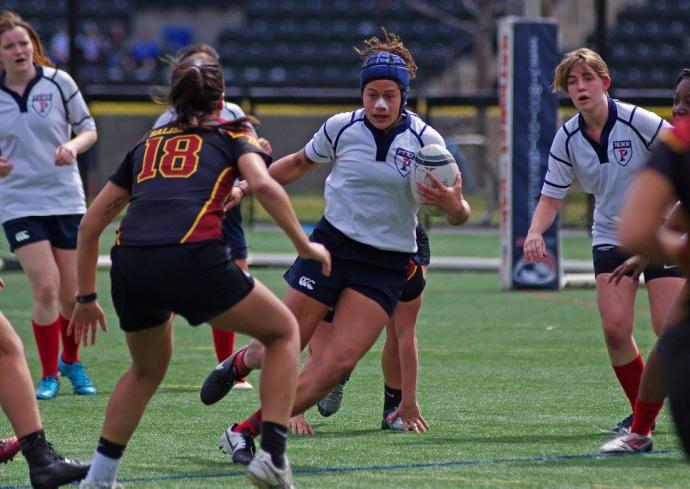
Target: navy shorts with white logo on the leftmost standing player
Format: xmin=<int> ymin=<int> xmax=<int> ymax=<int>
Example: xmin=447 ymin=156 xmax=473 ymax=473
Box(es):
xmin=2 ymin=214 xmax=82 ymax=251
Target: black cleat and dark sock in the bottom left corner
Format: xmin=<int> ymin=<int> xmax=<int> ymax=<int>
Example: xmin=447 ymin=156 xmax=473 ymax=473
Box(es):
xmin=22 ymin=435 xmax=91 ymax=489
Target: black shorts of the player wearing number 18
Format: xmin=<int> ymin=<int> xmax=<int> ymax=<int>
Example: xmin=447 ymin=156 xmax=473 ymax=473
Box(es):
xmin=110 ymin=241 xmax=254 ymax=331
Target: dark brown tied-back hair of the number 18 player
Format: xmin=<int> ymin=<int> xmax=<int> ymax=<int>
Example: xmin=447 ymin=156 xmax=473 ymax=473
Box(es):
xmin=151 ymin=52 xmax=258 ymax=130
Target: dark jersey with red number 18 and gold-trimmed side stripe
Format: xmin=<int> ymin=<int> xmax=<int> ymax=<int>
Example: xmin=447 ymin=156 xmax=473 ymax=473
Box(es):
xmin=110 ymin=125 xmax=270 ymax=246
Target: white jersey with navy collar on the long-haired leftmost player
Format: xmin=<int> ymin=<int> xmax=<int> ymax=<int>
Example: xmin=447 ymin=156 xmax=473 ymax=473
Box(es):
xmin=0 ymin=66 xmax=96 ymax=222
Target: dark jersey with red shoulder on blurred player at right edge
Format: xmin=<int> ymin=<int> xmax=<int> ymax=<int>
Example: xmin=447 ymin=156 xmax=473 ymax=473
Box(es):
xmin=647 ymin=117 xmax=690 ymax=211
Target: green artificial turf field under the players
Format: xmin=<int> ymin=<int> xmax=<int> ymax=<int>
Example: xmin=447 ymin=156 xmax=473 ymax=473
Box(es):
xmin=0 ymin=230 xmax=689 ymax=489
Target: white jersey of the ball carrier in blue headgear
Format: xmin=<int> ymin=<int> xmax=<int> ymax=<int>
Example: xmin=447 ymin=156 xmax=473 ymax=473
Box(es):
xmin=304 ymin=109 xmax=445 ymax=253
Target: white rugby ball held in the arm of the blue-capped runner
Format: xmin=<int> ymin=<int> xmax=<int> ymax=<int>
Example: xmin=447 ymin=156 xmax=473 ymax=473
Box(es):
xmin=410 ymin=144 xmax=460 ymax=216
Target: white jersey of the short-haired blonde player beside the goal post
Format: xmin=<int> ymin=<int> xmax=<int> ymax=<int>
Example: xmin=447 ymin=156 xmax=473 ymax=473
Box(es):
xmin=541 ymin=99 xmax=670 ymax=246
